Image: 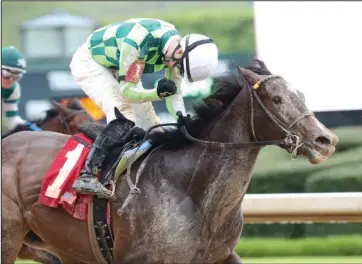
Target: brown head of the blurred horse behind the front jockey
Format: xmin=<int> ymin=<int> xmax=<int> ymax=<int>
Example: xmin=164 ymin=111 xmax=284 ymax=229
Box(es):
xmin=53 ymin=98 xmax=95 ymax=134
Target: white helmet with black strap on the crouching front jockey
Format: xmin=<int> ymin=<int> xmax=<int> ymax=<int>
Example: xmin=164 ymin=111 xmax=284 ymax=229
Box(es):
xmin=180 ymin=34 xmax=218 ymax=82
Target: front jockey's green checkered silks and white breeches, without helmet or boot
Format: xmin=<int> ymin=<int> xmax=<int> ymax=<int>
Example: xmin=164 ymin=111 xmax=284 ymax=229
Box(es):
xmin=70 ymin=19 xmax=186 ymax=126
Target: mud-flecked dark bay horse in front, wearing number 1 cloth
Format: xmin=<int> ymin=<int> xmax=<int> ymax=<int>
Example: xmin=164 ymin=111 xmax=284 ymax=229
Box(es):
xmin=2 ymin=60 xmax=338 ymax=264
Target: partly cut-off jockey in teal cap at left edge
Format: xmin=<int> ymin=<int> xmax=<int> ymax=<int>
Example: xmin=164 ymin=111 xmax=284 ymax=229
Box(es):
xmin=1 ymin=46 xmax=40 ymax=130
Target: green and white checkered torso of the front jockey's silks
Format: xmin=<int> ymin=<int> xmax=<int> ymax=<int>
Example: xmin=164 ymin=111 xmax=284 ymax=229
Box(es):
xmin=88 ymin=19 xmax=179 ymax=76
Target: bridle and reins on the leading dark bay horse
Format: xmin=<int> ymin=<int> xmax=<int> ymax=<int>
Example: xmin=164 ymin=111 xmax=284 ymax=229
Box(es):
xmin=177 ymin=75 xmax=314 ymax=157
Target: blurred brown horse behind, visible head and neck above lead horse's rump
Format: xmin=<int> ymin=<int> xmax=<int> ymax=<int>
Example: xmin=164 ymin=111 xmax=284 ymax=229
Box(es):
xmin=1 ymin=98 xmax=95 ymax=139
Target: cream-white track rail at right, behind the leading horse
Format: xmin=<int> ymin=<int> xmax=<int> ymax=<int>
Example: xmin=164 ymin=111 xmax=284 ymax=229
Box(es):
xmin=241 ymin=192 xmax=362 ymax=223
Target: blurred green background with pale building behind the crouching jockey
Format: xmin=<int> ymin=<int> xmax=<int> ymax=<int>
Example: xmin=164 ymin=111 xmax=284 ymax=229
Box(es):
xmin=2 ymin=1 xmax=255 ymax=122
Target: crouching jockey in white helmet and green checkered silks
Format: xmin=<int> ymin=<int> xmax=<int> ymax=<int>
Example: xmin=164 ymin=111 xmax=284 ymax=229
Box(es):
xmin=70 ymin=19 xmax=218 ymax=198
